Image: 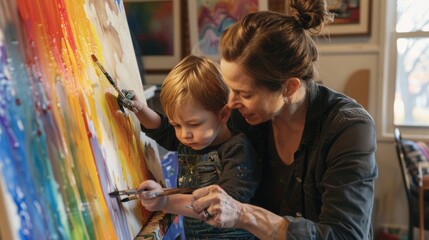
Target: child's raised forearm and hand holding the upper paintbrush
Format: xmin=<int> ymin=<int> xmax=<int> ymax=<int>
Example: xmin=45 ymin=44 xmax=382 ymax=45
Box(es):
xmin=118 ymin=90 xmax=161 ymax=129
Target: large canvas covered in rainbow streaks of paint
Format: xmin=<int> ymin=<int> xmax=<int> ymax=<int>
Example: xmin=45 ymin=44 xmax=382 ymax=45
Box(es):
xmin=0 ymin=0 xmax=153 ymax=239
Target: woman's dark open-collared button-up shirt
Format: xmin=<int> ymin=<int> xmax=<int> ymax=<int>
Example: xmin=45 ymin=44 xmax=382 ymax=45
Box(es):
xmin=230 ymin=83 xmax=378 ymax=239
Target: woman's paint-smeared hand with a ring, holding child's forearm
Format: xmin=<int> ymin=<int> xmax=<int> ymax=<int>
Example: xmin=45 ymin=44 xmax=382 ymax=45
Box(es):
xmin=192 ymin=185 xmax=244 ymax=228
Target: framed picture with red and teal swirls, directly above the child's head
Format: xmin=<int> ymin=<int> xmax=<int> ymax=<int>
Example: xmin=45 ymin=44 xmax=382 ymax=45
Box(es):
xmin=188 ymin=0 xmax=268 ymax=61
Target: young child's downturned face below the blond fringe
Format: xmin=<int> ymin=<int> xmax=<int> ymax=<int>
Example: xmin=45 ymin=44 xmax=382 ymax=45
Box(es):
xmin=169 ymin=101 xmax=227 ymax=150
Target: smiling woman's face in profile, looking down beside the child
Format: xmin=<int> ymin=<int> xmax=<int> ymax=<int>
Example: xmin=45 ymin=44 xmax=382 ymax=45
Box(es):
xmin=220 ymin=60 xmax=285 ymax=125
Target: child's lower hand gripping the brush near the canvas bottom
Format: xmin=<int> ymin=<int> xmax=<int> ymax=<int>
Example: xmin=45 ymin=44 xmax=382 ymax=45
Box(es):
xmin=137 ymin=180 xmax=168 ymax=212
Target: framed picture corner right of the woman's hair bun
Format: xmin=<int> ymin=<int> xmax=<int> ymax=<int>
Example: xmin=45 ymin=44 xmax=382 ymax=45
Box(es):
xmin=322 ymin=0 xmax=371 ymax=36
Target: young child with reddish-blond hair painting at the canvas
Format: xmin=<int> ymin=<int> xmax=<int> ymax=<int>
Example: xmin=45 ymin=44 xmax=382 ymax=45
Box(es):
xmin=119 ymin=55 xmax=261 ymax=239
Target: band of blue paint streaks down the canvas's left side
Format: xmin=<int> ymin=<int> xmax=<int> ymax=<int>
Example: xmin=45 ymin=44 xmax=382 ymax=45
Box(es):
xmin=0 ymin=25 xmax=69 ymax=239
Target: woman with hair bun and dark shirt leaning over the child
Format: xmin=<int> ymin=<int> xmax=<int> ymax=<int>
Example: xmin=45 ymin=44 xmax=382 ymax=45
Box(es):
xmin=192 ymin=0 xmax=377 ymax=239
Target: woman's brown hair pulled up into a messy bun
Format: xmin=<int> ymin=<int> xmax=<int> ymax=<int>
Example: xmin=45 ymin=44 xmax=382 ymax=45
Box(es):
xmin=219 ymin=0 xmax=333 ymax=91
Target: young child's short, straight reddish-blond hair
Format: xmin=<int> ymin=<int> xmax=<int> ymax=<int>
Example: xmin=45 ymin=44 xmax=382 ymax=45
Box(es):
xmin=160 ymin=55 xmax=229 ymax=118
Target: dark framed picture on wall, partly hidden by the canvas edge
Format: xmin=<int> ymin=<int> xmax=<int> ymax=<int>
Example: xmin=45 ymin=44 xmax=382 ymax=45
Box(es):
xmin=124 ymin=0 xmax=182 ymax=74
